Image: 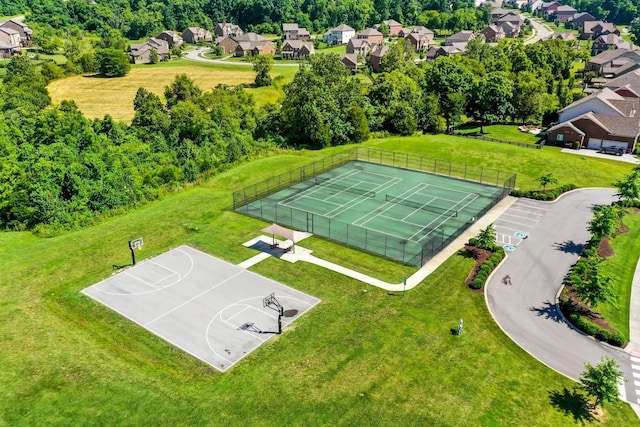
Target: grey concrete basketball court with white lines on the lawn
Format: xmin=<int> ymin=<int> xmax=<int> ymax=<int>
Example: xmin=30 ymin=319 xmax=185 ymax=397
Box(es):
xmin=82 ymin=246 xmax=320 ymax=372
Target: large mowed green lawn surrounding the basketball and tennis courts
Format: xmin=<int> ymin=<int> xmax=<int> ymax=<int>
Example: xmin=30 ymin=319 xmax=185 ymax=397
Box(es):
xmin=0 ymin=136 xmax=640 ymax=426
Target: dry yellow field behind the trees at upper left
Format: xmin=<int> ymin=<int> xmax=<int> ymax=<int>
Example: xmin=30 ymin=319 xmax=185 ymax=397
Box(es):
xmin=48 ymin=65 xmax=280 ymax=122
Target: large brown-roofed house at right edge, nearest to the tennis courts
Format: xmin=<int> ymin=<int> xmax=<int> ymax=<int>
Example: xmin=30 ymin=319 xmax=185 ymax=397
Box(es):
xmin=547 ymin=87 xmax=640 ymax=151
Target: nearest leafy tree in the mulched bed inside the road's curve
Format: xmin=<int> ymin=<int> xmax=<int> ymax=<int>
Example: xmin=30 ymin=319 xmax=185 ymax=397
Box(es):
xmin=567 ymin=255 xmax=616 ymax=308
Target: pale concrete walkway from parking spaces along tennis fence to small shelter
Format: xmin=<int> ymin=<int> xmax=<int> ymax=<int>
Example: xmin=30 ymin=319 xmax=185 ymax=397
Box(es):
xmin=238 ymin=196 xmax=518 ymax=292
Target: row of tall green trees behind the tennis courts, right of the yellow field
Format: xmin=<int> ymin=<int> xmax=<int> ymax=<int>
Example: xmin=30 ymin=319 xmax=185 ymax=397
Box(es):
xmin=259 ymin=39 xmax=583 ymax=148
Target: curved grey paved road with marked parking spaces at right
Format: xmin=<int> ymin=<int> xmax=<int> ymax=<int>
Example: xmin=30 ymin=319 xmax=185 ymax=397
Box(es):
xmin=486 ymin=189 xmax=640 ymax=412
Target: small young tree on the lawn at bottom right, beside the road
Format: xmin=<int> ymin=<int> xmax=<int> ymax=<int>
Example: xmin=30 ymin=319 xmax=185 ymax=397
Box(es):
xmin=580 ymin=356 xmax=623 ymax=407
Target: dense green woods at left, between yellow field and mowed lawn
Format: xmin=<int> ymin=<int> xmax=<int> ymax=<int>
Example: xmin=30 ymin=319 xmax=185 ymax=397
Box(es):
xmin=0 ymin=56 xmax=273 ymax=233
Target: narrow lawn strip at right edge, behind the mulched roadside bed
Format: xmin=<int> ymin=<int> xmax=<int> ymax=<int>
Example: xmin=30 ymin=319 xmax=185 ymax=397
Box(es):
xmin=597 ymin=214 xmax=640 ymax=341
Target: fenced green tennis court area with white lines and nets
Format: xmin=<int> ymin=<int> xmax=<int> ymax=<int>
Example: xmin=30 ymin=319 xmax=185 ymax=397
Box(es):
xmin=234 ymin=149 xmax=508 ymax=265
